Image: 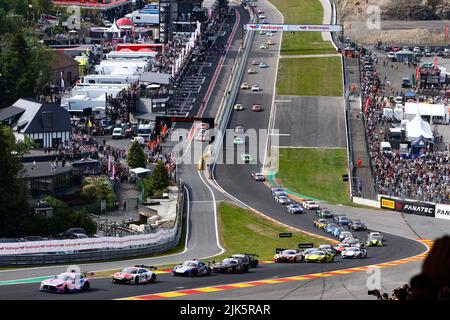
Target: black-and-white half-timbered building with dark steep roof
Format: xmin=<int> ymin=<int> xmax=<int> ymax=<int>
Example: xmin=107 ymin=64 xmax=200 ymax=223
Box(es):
xmin=0 ymin=99 xmax=72 ymax=148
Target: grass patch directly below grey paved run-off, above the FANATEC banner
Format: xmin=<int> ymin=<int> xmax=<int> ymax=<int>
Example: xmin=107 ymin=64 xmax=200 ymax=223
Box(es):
xmin=277 ymin=148 xmax=350 ymax=205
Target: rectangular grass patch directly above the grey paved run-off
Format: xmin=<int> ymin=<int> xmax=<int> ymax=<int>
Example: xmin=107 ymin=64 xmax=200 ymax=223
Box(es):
xmin=277 ymin=57 xmax=342 ymax=96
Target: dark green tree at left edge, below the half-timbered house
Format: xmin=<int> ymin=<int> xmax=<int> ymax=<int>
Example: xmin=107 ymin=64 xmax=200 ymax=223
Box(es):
xmin=0 ymin=126 xmax=28 ymax=237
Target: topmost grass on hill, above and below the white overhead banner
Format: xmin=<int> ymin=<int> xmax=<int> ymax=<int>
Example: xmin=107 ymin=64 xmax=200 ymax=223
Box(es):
xmin=269 ymin=0 xmax=336 ymax=55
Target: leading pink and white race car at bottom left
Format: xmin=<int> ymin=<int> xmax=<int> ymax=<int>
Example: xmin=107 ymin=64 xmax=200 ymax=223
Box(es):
xmin=39 ymin=272 xmax=94 ymax=293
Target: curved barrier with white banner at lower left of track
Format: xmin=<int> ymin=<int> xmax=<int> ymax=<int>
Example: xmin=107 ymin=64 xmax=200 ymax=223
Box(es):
xmin=0 ymin=179 xmax=185 ymax=266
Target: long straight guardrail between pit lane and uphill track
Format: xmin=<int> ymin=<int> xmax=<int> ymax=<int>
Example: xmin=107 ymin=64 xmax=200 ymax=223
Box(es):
xmin=211 ymin=5 xmax=257 ymax=164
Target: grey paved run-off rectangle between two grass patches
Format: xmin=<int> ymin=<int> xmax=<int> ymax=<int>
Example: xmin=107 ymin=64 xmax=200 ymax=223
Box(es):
xmin=274 ymin=96 xmax=347 ymax=148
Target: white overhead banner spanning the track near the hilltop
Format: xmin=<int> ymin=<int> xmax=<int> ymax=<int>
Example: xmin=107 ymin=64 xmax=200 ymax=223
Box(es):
xmin=245 ymin=23 xmax=342 ymax=32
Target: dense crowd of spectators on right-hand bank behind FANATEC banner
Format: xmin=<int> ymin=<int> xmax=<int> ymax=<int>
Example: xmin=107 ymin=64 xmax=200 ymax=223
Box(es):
xmin=361 ymin=48 xmax=450 ymax=203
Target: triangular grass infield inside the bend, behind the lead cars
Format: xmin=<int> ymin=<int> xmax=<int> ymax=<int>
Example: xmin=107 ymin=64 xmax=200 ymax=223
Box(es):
xmin=214 ymin=202 xmax=327 ymax=260
